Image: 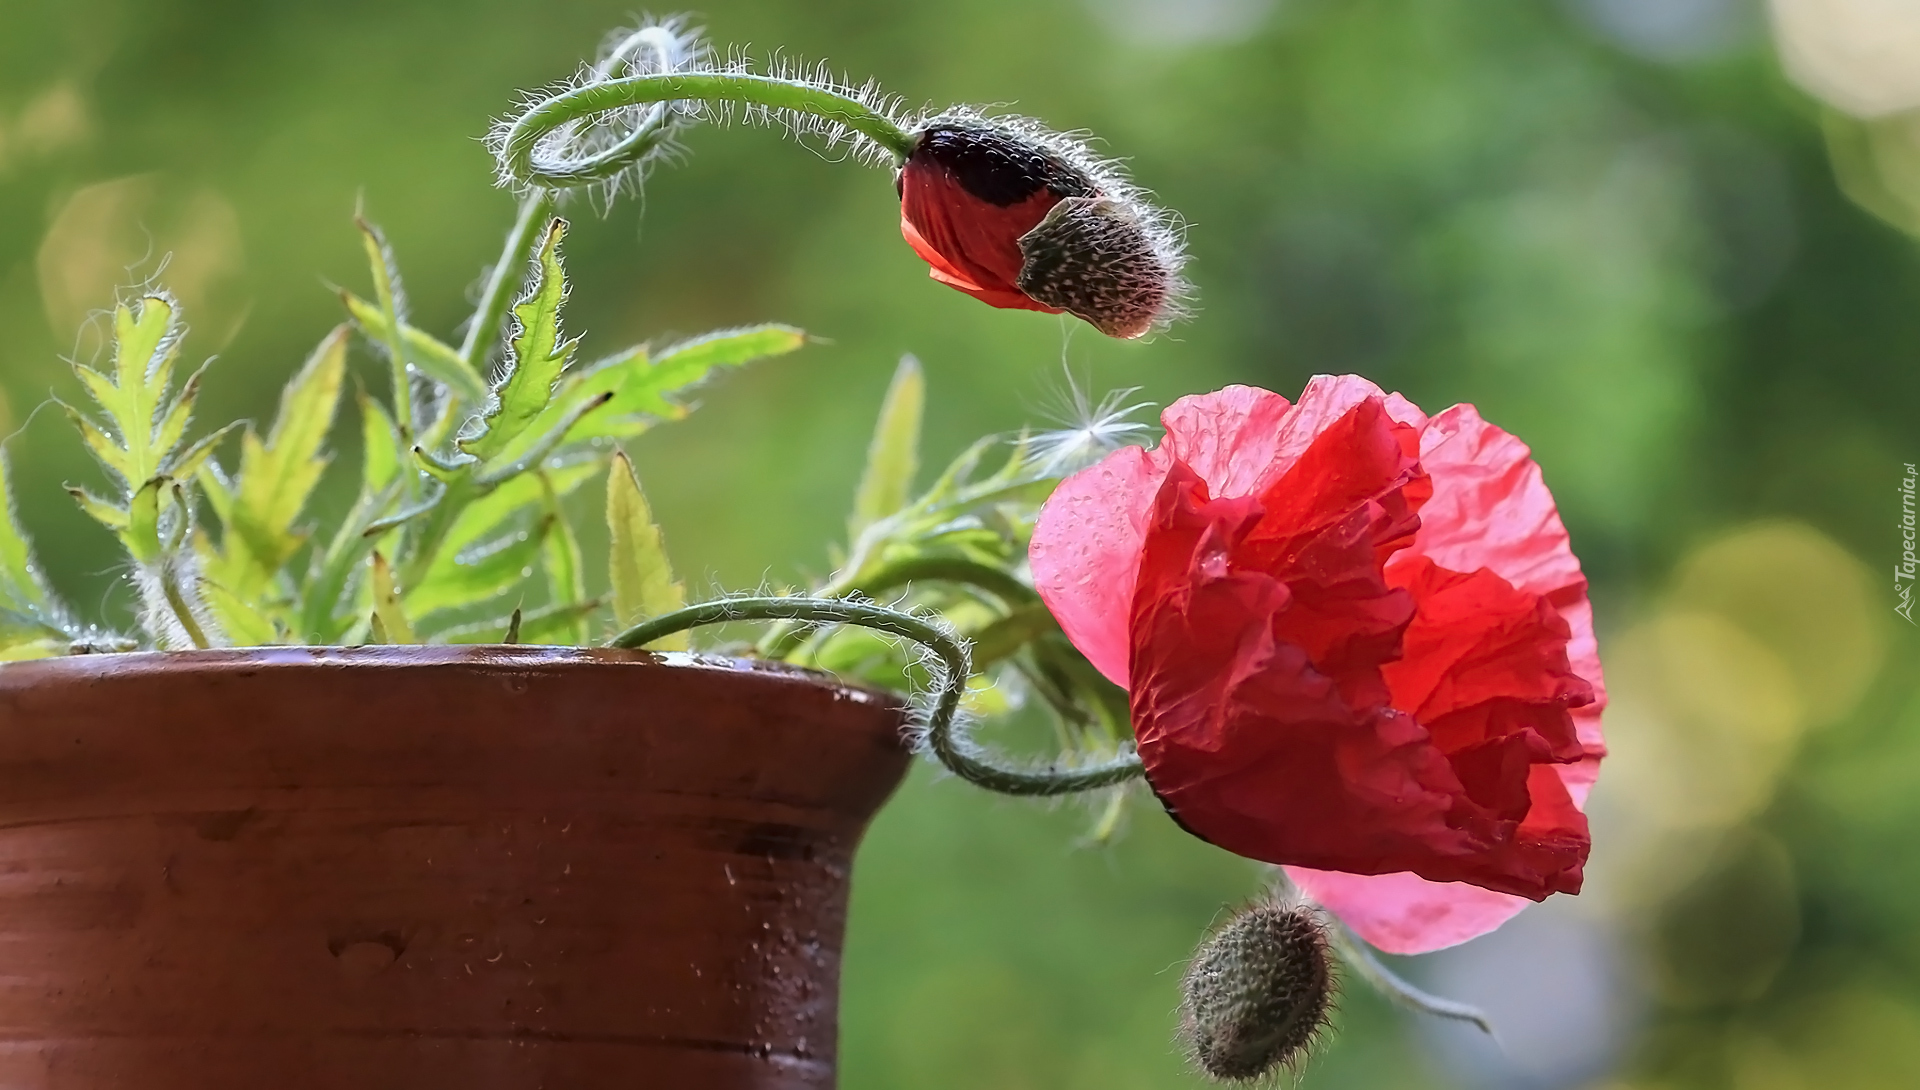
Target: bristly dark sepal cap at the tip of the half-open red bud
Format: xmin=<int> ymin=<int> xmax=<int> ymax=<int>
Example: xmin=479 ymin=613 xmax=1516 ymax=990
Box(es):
xmin=1018 ymin=198 xmax=1173 ymax=338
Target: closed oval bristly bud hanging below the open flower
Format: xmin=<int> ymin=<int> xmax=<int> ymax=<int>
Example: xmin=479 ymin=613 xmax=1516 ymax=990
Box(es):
xmin=1181 ymin=902 xmax=1334 ymax=1082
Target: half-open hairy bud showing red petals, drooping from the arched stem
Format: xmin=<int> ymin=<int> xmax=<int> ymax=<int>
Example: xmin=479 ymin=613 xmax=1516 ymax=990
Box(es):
xmin=897 ymin=111 xmax=1185 ymax=338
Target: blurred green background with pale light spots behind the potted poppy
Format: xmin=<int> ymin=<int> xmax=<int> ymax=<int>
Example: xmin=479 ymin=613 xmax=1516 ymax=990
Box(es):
xmin=0 ymin=0 xmax=1920 ymax=1090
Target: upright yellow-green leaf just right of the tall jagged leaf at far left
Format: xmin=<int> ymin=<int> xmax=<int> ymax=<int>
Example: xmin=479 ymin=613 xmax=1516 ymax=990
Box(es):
xmin=223 ymin=326 xmax=348 ymax=599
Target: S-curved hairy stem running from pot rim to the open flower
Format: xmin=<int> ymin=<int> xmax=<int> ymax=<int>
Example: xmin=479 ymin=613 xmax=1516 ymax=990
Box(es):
xmin=609 ymin=599 xmax=1140 ymax=796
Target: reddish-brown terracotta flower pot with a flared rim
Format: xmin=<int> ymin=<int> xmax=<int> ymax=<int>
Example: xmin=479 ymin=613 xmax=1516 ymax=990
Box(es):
xmin=0 ymin=647 xmax=908 ymax=1090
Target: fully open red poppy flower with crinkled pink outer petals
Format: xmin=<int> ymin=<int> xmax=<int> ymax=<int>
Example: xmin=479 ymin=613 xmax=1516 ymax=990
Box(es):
xmin=1031 ymin=376 xmax=1605 ymax=952
